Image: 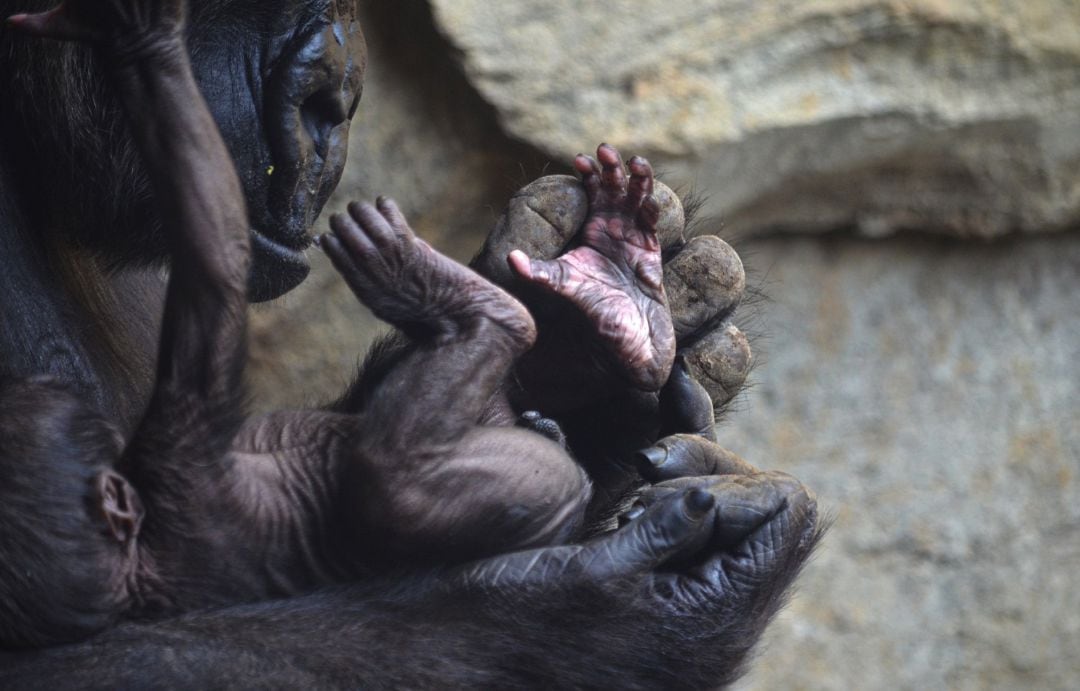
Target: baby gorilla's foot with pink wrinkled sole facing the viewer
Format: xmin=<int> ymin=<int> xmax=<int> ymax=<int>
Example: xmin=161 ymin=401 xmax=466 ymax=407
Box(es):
xmin=509 ymin=145 xmax=675 ymax=391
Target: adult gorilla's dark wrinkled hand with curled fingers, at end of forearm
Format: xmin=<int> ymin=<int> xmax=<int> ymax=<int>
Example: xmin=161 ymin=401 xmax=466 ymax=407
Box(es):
xmin=451 ymin=436 xmax=822 ymax=689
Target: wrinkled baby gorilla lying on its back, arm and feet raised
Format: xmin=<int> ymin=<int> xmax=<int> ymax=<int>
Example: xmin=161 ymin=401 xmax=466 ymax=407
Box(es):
xmin=0 ymin=0 xmax=674 ymax=647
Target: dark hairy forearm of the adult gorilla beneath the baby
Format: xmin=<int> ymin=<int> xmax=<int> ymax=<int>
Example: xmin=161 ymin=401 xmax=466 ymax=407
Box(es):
xmin=0 ymin=579 xmax=734 ymax=689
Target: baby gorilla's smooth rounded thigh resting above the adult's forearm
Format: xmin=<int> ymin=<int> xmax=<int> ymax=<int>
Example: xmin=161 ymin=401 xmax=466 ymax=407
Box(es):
xmin=355 ymin=426 xmax=592 ymax=564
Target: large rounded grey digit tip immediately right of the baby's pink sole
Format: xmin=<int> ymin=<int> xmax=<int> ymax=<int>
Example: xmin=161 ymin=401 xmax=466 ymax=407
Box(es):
xmin=664 ymin=235 xmax=746 ymax=339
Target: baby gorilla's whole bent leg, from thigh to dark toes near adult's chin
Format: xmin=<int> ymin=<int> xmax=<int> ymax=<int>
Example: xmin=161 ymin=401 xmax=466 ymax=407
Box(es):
xmin=320 ymin=199 xmax=589 ymax=561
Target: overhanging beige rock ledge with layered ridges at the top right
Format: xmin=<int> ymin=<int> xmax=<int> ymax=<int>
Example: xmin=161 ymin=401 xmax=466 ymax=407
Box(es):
xmin=431 ymin=0 xmax=1080 ymax=235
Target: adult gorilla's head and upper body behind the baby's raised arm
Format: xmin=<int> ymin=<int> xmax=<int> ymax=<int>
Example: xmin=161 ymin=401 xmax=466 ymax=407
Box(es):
xmin=0 ymin=0 xmax=366 ymax=429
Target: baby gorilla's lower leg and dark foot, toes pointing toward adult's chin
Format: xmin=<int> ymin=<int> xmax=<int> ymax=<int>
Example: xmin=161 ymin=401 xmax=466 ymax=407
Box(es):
xmin=319 ymin=194 xmax=536 ymax=441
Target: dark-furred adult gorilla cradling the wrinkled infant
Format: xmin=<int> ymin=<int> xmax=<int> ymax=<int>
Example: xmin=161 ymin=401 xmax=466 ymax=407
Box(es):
xmin=0 ymin=0 xmax=818 ymax=688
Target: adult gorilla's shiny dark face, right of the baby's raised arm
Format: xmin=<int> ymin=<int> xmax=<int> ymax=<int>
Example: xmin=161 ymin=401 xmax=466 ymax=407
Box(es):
xmin=189 ymin=0 xmax=367 ymax=301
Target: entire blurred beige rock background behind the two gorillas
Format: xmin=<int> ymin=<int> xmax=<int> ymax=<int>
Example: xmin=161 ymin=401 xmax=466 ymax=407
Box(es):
xmin=252 ymin=0 xmax=1080 ymax=689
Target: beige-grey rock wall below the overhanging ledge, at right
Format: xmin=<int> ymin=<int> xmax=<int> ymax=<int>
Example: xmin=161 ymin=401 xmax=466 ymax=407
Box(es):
xmin=720 ymin=234 xmax=1080 ymax=691
